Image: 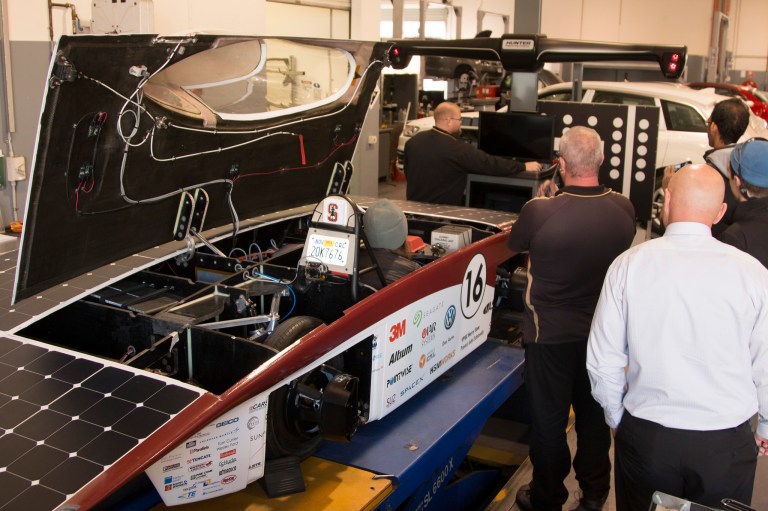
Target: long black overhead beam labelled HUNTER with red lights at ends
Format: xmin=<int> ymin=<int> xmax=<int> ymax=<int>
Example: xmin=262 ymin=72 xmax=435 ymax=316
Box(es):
xmin=388 ymin=34 xmax=688 ymax=79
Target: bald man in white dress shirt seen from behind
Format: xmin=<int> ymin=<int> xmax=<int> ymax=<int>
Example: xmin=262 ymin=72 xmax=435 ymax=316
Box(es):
xmin=587 ymin=165 xmax=768 ymax=511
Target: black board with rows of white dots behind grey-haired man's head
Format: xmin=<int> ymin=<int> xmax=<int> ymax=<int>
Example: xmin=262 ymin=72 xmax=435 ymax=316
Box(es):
xmin=539 ymin=101 xmax=659 ymax=221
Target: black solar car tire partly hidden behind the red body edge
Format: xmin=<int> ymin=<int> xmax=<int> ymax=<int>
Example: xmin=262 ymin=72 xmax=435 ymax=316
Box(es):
xmin=264 ymin=316 xmax=344 ymax=459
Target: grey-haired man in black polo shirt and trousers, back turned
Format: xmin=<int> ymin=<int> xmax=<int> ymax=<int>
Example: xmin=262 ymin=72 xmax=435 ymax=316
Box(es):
xmin=509 ymin=126 xmax=635 ymax=511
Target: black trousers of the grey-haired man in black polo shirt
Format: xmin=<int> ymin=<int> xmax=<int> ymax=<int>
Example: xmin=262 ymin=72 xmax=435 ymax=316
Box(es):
xmin=525 ymin=340 xmax=608 ymax=511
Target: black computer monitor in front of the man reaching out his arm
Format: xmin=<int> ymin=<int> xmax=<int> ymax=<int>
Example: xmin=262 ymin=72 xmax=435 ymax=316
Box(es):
xmin=477 ymin=112 xmax=555 ymax=161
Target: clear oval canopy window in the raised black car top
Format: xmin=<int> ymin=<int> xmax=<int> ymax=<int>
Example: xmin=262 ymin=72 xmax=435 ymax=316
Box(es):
xmin=144 ymin=39 xmax=355 ymax=120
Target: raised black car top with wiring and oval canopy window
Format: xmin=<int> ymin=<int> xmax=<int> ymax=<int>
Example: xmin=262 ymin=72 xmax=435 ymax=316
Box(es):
xmin=15 ymin=35 xmax=389 ymax=300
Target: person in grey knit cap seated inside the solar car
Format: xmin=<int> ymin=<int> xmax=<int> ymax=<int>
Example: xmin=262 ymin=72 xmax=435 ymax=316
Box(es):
xmin=357 ymin=199 xmax=421 ymax=289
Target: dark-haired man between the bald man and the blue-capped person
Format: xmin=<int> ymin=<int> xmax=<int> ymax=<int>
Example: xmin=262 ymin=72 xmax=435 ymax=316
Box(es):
xmin=704 ymin=98 xmax=749 ymax=236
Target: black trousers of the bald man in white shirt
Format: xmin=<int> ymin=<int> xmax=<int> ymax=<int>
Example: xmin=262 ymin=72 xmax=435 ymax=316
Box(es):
xmin=614 ymin=411 xmax=757 ymax=511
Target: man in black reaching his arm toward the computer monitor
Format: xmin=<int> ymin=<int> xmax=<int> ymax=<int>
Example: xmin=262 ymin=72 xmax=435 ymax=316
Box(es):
xmin=404 ymin=101 xmax=541 ymax=206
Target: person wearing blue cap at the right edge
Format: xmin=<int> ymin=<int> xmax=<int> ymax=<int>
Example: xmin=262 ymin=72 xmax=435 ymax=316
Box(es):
xmin=719 ymin=138 xmax=768 ymax=268
